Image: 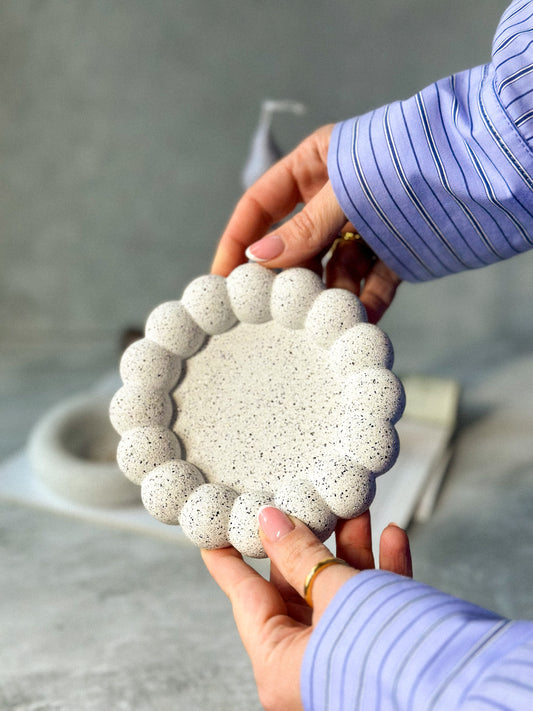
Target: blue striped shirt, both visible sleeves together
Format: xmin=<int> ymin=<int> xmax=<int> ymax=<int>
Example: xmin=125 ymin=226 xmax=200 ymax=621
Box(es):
xmin=308 ymin=0 xmax=533 ymax=711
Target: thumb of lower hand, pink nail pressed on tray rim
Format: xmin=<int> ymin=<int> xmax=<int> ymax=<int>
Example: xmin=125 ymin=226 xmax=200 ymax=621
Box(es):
xmin=258 ymin=506 xmax=358 ymax=617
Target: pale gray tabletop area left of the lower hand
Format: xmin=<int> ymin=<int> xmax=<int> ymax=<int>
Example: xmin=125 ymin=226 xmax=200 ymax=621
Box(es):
xmin=0 ymin=502 xmax=260 ymax=711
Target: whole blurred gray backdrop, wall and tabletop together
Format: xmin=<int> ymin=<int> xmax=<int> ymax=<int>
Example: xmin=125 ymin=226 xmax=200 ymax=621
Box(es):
xmin=0 ymin=0 xmax=533 ymax=711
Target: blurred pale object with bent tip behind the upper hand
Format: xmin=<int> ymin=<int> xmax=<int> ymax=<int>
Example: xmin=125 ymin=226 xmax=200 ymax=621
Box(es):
xmin=242 ymin=99 xmax=305 ymax=190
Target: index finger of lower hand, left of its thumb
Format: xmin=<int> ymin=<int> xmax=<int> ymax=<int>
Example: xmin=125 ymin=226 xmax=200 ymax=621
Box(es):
xmin=202 ymin=548 xmax=286 ymax=652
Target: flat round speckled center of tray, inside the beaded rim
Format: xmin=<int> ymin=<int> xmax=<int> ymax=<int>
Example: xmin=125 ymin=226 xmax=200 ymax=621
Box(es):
xmin=173 ymin=321 xmax=340 ymax=492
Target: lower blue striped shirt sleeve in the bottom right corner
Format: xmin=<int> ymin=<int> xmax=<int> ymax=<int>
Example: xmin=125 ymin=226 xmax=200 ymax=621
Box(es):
xmin=301 ymin=570 xmax=533 ymax=711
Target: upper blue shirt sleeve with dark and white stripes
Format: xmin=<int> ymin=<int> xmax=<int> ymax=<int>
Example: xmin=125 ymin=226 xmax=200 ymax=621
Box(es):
xmin=328 ymin=0 xmax=533 ymax=281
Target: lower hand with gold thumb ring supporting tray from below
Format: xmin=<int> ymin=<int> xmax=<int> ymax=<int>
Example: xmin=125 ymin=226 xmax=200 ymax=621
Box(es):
xmin=202 ymin=507 xmax=412 ymax=711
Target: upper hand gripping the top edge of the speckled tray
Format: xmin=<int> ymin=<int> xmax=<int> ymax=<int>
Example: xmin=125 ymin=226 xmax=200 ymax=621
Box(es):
xmin=211 ymin=125 xmax=400 ymax=323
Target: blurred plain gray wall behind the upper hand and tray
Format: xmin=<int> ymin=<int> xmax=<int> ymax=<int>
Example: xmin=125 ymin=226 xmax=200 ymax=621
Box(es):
xmin=0 ymin=0 xmax=533 ymax=378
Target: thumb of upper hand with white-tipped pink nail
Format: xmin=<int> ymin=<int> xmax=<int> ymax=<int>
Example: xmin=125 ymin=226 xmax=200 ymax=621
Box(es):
xmin=246 ymin=181 xmax=346 ymax=269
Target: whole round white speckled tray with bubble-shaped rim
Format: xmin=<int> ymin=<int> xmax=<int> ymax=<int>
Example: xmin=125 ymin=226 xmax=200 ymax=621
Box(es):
xmin=110 ymin=264 xmax=405 ymax=557
